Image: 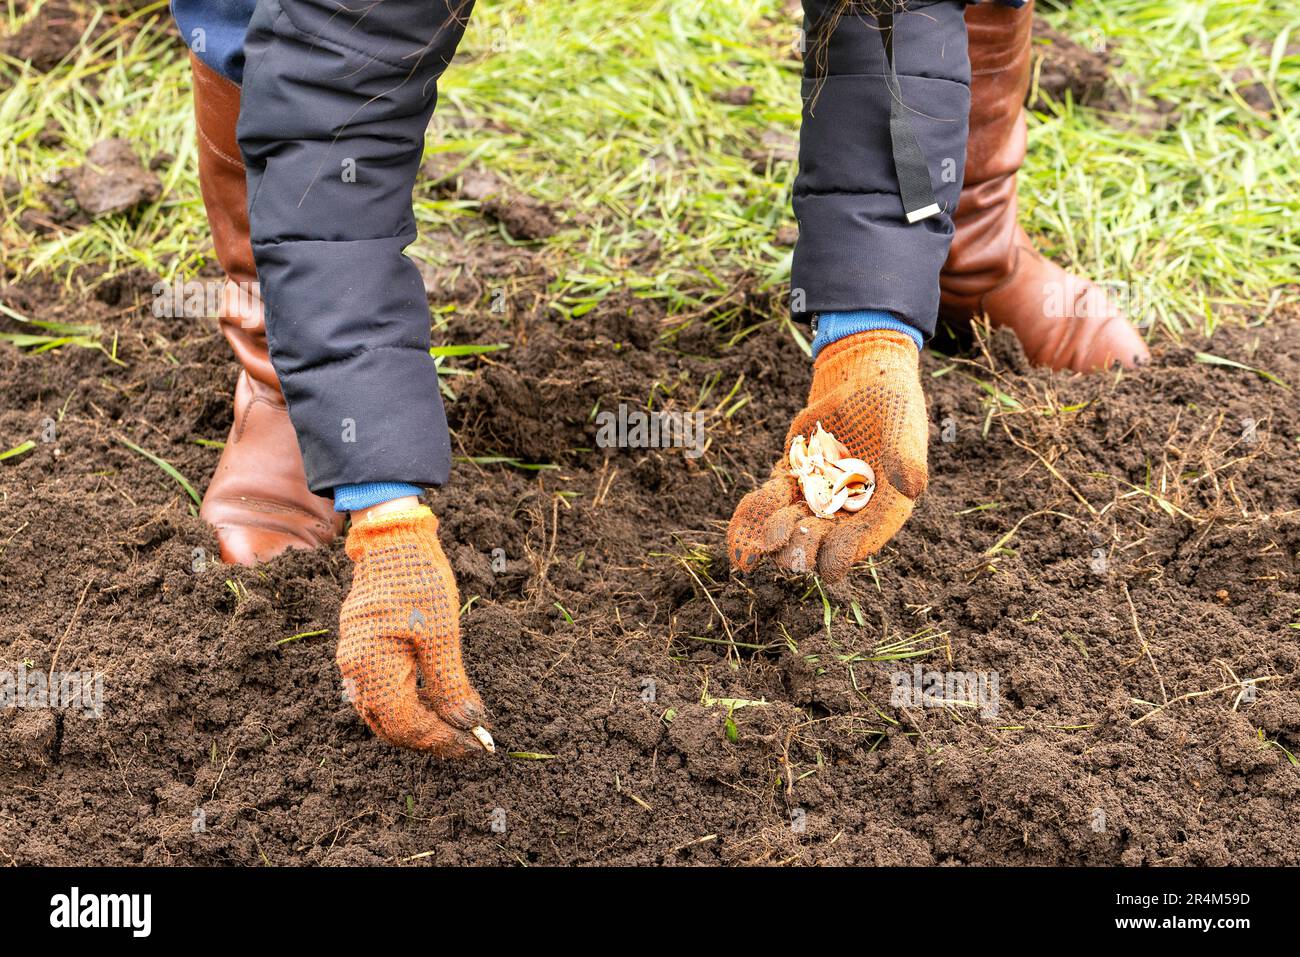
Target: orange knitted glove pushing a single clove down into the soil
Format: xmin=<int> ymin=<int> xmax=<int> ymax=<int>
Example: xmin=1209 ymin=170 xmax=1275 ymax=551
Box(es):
xmin=338 ymin=506 xmax=486 ymax=758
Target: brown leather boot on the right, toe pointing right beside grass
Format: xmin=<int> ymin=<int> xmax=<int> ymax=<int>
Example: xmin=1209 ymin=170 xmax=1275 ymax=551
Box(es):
xmin=940 ymin=0 xmax=1149 ymax=372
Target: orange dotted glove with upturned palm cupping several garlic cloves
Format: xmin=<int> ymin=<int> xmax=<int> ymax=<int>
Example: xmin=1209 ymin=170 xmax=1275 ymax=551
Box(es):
xmin=727 ymin=330 xmax=930 ymax=581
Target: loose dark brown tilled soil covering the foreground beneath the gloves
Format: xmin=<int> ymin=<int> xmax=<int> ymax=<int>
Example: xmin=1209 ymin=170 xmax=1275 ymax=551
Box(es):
xmin=0 ymin=254 xmax=1300 ymax=865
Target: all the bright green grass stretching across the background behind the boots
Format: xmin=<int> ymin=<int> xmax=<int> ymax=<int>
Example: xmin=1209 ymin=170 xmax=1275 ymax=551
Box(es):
xmin=0 ymin=0 xmax=1300 ymax=334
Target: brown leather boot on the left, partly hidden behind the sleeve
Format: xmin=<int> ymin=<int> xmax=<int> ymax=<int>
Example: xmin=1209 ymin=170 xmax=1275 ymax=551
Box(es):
xmin=190 ymin=55 xmax=343 ymax=564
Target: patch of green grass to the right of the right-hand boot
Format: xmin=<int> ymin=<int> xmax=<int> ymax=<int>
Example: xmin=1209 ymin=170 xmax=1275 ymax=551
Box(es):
xmin=1021 ymin=0 xmax=1300 ymax=332
